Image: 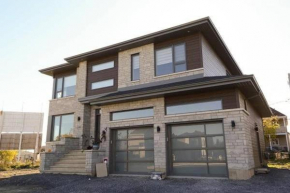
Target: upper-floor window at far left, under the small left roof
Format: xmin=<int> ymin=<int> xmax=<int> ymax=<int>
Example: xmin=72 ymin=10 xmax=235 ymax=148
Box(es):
xmin=54 ymin=75 xmax=76 ymax=98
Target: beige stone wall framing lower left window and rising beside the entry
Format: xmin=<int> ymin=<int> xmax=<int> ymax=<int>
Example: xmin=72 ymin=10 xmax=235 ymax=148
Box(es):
xmin=47 ymin=61 xmax=90 ymax=147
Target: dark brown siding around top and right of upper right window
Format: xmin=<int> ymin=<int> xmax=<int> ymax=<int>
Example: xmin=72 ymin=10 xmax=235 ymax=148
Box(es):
xmin=154 ymin=33 xmax=202 ymax=70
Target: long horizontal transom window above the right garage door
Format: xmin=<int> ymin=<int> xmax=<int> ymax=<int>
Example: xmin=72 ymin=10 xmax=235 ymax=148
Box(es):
xmin=166 ymin=100 xmax=222 ymax=115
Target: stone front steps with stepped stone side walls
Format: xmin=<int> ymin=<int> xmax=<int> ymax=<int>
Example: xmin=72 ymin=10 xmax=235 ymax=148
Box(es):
xmin=39 ymin=137 xmax=105 ymax=176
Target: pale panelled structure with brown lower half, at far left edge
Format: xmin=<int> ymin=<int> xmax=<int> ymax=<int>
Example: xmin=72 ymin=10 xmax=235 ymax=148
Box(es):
xmin=0 ymin=111 xmax=43 ymax=159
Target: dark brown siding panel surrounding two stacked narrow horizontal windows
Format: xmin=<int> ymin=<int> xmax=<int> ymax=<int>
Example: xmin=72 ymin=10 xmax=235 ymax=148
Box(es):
xmin=87 ymin=55 xmax=118 ymax=96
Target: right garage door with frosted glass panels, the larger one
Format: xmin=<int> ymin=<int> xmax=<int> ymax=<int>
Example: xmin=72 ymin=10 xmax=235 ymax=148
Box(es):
xmin=167 ymin=123 xmax=228 ymax=177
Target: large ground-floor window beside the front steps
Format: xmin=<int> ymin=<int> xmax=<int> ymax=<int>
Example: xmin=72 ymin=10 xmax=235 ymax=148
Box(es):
xmin=51 ymin=114 xmax=74 ymax=141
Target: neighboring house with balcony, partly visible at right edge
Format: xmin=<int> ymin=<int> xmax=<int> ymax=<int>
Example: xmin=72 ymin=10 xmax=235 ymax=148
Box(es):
xmin=266 ymin=108 xmax=290 ymax=152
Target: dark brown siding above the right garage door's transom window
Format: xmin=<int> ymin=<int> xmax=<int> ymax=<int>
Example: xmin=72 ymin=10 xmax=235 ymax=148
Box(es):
xmin=165 ymin=89 xmax=238 ymax=109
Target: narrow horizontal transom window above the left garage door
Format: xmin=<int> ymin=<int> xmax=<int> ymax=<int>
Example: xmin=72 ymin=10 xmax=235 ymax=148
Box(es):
xmin=111 ymin=108 xmax=154 ymax=121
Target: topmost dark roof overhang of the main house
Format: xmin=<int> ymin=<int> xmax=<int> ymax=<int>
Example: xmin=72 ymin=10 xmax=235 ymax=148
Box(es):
xmin=65 ymin=17 xmax=242 ymax=75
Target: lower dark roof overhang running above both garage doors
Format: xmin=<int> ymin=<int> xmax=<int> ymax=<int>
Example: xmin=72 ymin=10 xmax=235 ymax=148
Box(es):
xmin=79 ymin=75 xmax=272 ymax=117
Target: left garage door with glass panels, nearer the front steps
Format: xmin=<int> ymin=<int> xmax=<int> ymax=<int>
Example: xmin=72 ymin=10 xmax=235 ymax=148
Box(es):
xmin=112 ymin=127 xmax=154 ymax=174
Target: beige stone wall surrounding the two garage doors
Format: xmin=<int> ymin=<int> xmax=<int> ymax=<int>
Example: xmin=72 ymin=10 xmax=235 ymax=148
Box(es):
xmin=97 ymin=90 xmax=260 ymax=179
